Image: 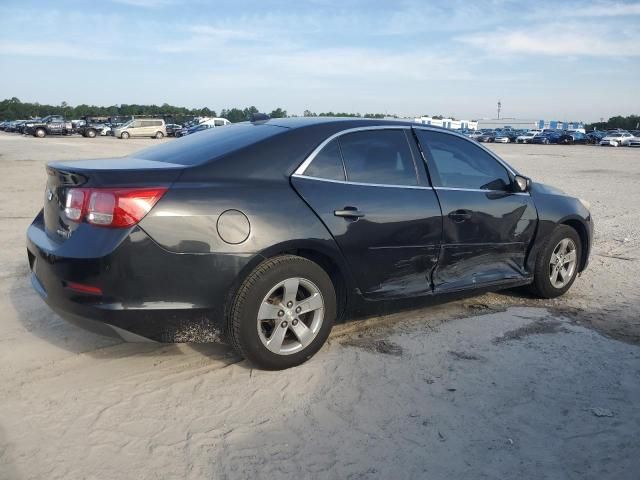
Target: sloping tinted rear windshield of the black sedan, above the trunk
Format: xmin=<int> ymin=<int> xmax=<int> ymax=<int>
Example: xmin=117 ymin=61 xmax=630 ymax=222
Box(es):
xmin=133 ymin=122 xmax=287 ymax=165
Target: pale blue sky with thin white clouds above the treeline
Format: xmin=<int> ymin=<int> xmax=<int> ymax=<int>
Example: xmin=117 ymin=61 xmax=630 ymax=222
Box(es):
xmin=0 ymin=0 xmax=640 ymax=121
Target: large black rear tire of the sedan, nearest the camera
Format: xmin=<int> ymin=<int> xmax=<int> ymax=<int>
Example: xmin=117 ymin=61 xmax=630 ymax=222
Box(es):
xmin=227 ymin=255 xmax=336 ymax=370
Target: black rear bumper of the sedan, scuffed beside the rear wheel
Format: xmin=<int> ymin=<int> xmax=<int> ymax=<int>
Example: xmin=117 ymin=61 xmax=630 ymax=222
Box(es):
xmin=27 ymin=215 xmax=251 ymax=342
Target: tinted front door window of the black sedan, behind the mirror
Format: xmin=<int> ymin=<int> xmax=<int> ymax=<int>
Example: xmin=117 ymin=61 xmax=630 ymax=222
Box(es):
xmin=416 ymin=130 xmax=511 ymax=191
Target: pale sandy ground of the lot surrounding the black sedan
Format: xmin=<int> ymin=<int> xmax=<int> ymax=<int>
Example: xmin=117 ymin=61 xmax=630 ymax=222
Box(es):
xmin=0 ymin=133 xmax=640 ymax=479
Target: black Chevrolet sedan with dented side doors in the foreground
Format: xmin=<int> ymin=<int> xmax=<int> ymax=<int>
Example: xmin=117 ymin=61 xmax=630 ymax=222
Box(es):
xmin=27 ymin=118 xmax=593 ymax=369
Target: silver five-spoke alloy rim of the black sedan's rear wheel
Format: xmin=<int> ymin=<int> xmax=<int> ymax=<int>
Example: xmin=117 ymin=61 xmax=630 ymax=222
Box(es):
xmin=257 ymin=277 xmax=325 ymax=355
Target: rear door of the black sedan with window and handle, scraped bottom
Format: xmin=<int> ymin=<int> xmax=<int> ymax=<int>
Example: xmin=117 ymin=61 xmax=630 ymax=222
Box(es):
xmin=292 ymin=128 xmax=442 ymax=299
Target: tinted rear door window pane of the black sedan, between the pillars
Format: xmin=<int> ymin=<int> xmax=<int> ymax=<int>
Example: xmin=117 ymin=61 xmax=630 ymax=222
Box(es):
xmin=339 ymin=130 xmax=418 ymax=186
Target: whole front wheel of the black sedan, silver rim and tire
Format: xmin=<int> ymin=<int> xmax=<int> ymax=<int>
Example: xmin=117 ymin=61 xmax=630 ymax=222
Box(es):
xmin=531 ymin=225 xmax=582 ymax=298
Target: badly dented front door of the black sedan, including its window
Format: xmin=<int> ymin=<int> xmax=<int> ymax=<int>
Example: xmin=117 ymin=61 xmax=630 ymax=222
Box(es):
xmin=415 ymin=128 xmax=538 ymax=291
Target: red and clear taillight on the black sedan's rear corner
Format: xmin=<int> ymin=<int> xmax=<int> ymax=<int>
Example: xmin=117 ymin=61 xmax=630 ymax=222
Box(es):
xmin=64 ymin=187 xmax=167 ymax=228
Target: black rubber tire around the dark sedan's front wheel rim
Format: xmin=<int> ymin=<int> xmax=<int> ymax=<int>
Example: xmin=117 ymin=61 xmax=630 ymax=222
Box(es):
xmin=530 ymin=225 xmax=582 ymax=298
